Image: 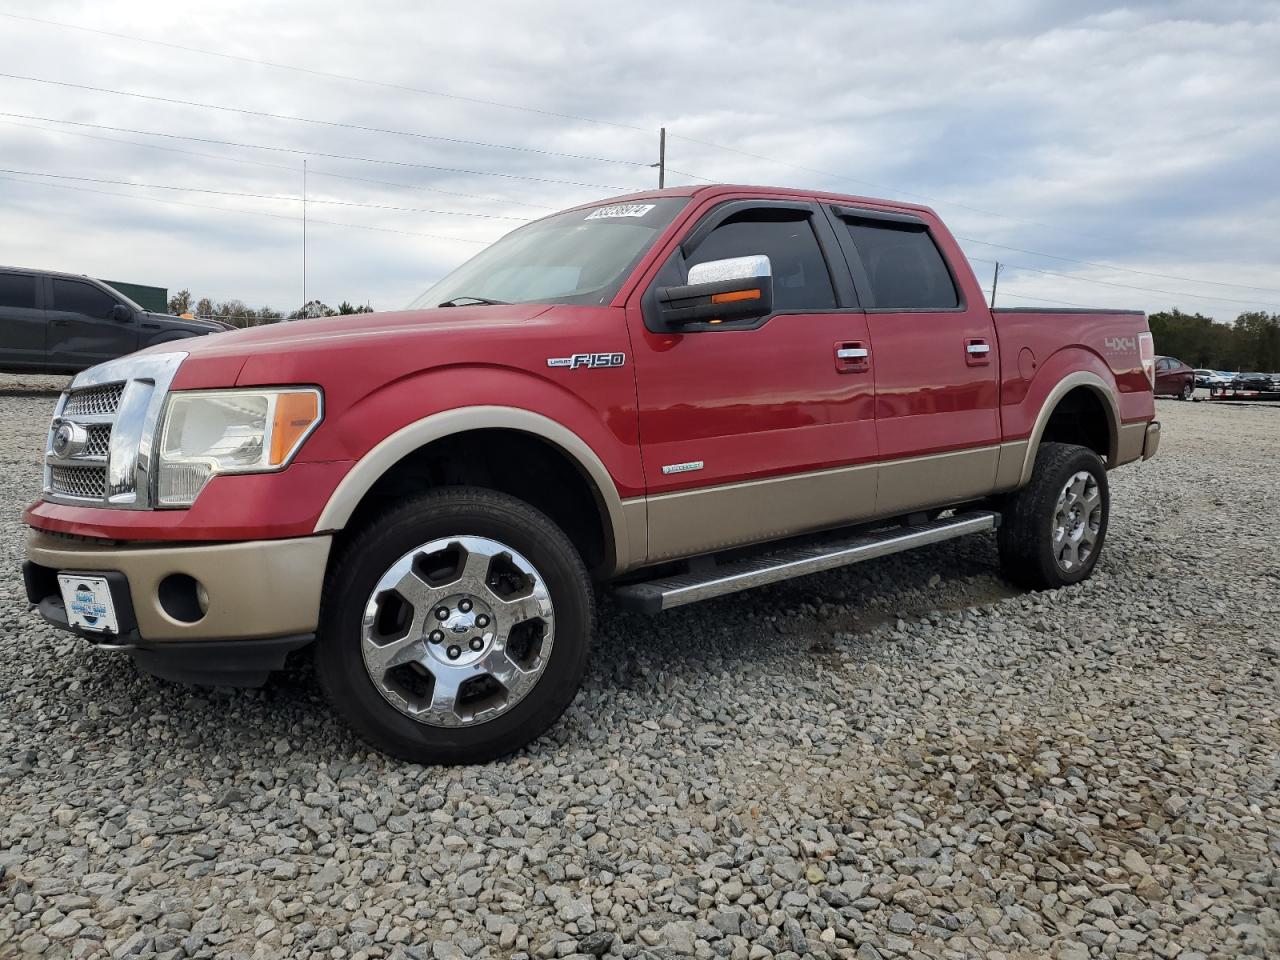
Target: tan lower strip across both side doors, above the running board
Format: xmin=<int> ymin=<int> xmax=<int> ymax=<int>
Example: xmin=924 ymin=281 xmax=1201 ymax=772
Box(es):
xmin=649 ymin=447 xmax=1003 ymax=563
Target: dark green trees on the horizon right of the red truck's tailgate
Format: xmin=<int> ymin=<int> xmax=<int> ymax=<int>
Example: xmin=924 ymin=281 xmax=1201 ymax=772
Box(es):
xmin=1147 ymin=308 xmax=1280 ymax=374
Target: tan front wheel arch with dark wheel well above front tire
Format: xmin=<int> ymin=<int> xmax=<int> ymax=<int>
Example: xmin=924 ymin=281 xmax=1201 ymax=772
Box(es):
xmin=315 ymin=407 xmax=632 ymax=576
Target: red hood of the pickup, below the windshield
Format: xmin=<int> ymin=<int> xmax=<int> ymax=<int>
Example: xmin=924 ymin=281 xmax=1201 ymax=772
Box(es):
xmin=150 ymin=303 xmax=552 ymax=362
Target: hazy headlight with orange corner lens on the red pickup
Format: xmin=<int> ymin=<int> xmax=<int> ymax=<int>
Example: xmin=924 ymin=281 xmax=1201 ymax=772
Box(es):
xmin=156 ymin=387 xmax=321 ymax=507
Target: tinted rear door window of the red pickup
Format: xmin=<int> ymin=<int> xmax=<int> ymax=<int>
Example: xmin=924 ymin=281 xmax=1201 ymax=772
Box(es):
xmin=845 ymin=219 xmax=960 ymax=310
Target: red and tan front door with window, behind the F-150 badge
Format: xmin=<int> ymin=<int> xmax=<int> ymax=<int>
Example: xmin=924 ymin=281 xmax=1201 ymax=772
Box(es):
xmin=627 ymin=201 xmax=877 ymax=562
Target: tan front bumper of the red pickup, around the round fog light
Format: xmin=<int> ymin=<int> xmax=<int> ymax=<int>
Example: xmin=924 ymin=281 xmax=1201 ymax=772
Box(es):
xmin=27 ymin=530 xmax=333 ymax=641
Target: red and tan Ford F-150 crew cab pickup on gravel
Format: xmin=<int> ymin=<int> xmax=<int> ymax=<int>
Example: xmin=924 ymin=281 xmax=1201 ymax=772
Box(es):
xmin=24 ymin=186 xmax=1160 ymax=762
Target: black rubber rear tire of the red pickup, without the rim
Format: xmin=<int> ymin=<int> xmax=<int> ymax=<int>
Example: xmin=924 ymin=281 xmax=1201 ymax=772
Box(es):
xmin=997 ymin=443 xmax=1111 ymax=590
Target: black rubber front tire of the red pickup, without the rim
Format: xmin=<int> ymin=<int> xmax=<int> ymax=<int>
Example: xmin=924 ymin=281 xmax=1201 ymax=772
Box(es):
xmin=315 ymin=486 xmax=595 ymax=764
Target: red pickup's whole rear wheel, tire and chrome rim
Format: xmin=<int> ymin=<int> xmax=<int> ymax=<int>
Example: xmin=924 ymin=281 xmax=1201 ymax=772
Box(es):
xmin=998 ymin=443 xmax=1111 ymax=590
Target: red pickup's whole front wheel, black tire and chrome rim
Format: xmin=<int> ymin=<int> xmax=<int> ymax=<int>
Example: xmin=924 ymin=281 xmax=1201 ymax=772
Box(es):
xmin=316 ymin=488 xmax=594 ymax=763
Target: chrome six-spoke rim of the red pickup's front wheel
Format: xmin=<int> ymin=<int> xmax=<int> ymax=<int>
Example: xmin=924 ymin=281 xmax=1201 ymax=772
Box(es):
xmin=361 ymin=536 xmax=556 ymax=727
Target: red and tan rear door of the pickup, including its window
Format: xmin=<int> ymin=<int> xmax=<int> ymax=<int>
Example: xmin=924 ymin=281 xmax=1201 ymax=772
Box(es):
xmin=828 ymin=205 xmax=1000 ymax=515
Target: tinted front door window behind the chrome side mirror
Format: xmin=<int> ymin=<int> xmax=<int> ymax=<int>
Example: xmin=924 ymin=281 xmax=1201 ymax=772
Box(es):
xmin=686 ymin=209 xmax=836 ymax=311
